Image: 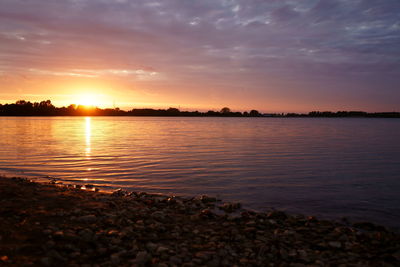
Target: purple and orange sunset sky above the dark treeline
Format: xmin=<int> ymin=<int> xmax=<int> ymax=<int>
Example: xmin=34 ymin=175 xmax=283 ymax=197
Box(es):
xmin=0 ymin=0 xmax=400 ymax=113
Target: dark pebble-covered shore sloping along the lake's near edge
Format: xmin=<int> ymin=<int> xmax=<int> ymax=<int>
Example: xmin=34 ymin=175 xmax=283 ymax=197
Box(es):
xmin=0 ymin=178 xmax=400 ymax=267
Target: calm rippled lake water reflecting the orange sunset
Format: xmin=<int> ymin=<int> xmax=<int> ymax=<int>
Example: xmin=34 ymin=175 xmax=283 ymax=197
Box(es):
xmin=0 ymin=117 xmax=400 ymax=227
